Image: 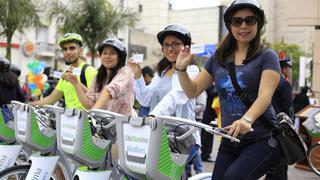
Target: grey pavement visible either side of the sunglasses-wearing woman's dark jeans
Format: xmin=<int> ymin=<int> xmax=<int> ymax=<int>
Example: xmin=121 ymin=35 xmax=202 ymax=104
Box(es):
xmin=198 ymin=138 xmax=320 ymax=180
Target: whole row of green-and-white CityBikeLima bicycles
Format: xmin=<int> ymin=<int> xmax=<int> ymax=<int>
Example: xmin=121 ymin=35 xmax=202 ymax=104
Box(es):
xmin=0 ymin=101 xmax=239 ymax=180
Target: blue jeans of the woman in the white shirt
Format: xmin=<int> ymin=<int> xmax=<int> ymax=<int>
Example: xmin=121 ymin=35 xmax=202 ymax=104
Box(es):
xmin=186 ymin=144 xmax=203 ymax=174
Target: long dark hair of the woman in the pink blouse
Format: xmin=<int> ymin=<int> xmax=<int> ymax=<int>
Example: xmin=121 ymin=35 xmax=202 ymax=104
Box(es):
xmin=95 ymin=47 xmax=126 ymax=92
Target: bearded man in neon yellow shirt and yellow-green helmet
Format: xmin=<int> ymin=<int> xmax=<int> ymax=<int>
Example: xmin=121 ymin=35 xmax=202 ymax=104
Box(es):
xmin=30 ymin=33 xmax=97 ymax=108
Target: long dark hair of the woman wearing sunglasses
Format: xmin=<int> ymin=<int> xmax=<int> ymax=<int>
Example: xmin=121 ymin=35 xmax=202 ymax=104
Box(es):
xmin=215 ymin=7 xmax=263 ymax=67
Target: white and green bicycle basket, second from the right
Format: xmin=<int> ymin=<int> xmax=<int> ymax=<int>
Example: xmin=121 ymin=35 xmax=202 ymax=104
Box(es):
xmin=57 ymin=109 xmax=111 ymax=168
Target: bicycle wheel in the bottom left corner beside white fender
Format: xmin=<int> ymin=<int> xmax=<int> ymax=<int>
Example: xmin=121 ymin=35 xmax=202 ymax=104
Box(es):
xmin=0 ymin=164 xmax=31 ymax=180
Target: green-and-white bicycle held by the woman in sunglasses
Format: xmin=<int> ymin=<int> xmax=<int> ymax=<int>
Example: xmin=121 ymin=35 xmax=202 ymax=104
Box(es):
xmin=113 ymin=116 xmax=240 ymax=180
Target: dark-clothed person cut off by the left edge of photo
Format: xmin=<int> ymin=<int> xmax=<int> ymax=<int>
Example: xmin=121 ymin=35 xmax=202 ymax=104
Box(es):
xmin=0 ymin=57 xmax=25 ymax=122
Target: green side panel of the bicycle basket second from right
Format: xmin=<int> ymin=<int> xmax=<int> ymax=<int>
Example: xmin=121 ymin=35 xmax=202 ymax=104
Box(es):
xmin=81 ymin=119 xmax=109 ymax=161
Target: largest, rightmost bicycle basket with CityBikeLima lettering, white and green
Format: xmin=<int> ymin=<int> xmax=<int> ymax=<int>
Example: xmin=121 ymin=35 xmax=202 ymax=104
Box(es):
xmin=116 ymin=117 xmax=188 ymax=179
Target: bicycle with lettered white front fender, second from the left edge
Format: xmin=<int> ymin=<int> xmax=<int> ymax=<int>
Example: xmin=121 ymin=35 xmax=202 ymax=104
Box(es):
xmin=0 ymin=101 xmax=73 ymax=180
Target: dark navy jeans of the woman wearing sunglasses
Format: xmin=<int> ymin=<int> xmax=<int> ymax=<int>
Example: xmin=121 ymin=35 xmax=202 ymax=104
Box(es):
xmin=212 ymin=137 xmax=282 ymax=180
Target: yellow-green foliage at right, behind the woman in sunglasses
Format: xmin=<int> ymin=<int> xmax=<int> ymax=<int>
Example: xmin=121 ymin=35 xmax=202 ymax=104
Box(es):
xmin=270 ymin=41 xmax=305 ymax=88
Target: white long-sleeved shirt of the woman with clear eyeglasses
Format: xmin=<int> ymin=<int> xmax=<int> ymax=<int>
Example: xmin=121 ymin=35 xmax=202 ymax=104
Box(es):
xmin=135 ymin=65 xmax=201 ymax=145
